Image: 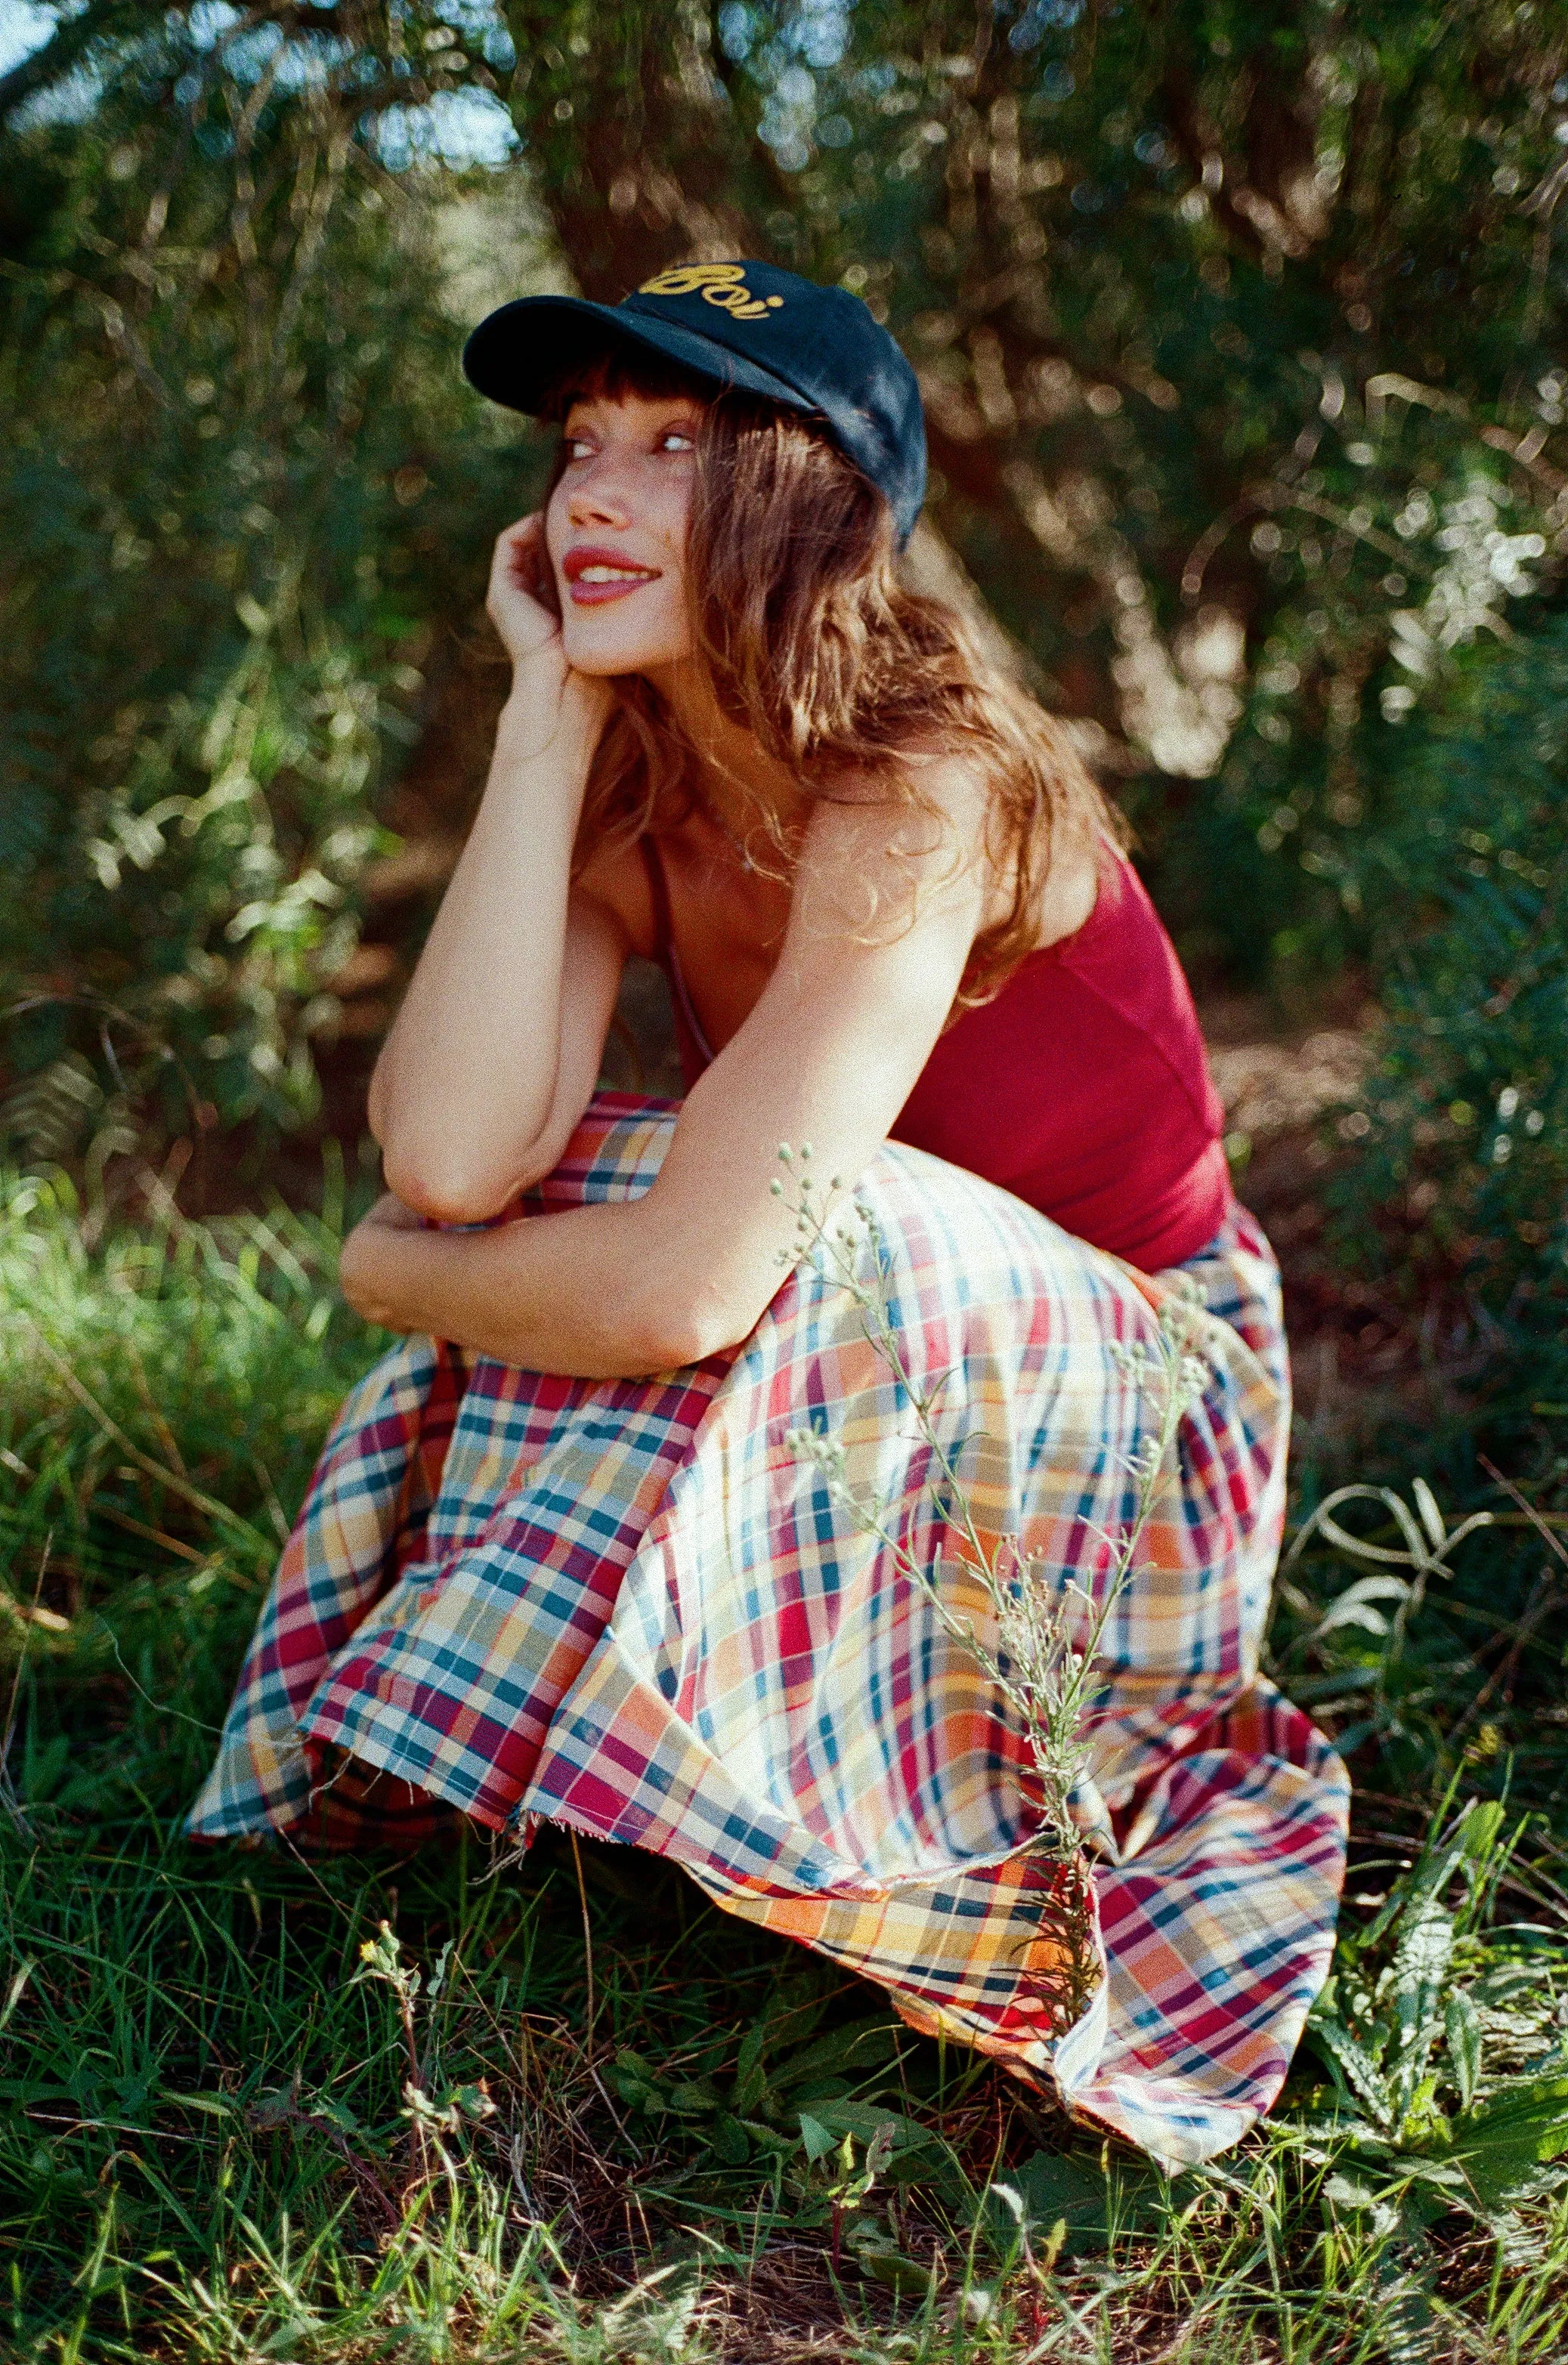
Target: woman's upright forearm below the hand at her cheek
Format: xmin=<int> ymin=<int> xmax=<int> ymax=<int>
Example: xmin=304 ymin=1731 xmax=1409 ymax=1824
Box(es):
xmin=371 ymin=681 xmax=603 ymax=1211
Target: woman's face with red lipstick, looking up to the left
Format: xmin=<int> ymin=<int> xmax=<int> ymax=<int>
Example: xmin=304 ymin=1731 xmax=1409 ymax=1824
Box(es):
xmin=544 ymin=380 xmax=703 ymax=674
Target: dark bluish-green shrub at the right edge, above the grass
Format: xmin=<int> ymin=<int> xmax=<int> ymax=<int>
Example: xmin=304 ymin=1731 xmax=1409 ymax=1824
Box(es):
xmin=1338 ymin=611 xmax=1568 ymax=1398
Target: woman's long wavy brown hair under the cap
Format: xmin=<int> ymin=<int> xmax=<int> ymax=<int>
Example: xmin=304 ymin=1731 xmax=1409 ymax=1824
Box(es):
xmin=546 ymin=348 xmax=1126 ymax=1005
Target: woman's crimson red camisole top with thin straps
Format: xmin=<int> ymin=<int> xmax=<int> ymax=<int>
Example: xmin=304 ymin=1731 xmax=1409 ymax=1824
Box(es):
xmin=641 ymin=837 xmax=1229 ymax=1272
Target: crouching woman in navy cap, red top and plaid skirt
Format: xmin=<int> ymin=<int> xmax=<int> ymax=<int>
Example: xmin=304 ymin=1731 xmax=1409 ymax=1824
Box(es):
xmin=192 ymin=262 xmax=1344 ymax=2162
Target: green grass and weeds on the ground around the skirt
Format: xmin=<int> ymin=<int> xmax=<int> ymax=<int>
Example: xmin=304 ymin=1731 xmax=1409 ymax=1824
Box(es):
xmin=0 ymin=1182 xmax=1568 ymax=2365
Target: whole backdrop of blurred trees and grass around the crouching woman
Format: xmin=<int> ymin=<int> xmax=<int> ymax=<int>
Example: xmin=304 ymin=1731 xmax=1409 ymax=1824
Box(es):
xmin=15 ymin=0 xmax=1568 ymax=2365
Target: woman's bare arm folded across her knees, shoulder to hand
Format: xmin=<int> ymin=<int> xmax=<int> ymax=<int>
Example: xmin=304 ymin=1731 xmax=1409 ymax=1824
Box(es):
xmin=345 ymin=785 xmax=984 ymax=1379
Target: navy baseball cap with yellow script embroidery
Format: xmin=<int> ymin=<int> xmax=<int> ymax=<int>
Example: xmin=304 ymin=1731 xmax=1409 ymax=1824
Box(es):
xmin=463 ymin=262 xmax=925 ymax=549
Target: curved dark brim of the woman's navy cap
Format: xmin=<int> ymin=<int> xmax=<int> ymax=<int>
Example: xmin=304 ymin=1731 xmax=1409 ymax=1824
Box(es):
xmin=463 ymin=295 xmax=816 ymax=416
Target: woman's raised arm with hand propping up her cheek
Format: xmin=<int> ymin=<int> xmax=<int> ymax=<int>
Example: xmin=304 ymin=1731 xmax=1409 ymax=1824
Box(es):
xmin=369 ymin=518 xmax=624 ymax=1223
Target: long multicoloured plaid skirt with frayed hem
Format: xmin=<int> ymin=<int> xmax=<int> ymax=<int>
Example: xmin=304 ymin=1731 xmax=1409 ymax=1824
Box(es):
xmin=189 ymin=1093 xmax=1348 ymax=2166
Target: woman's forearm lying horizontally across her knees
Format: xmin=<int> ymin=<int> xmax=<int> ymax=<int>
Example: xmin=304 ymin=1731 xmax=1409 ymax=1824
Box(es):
xmin=341 ymin=1192 xmax=766 ymax=1379
